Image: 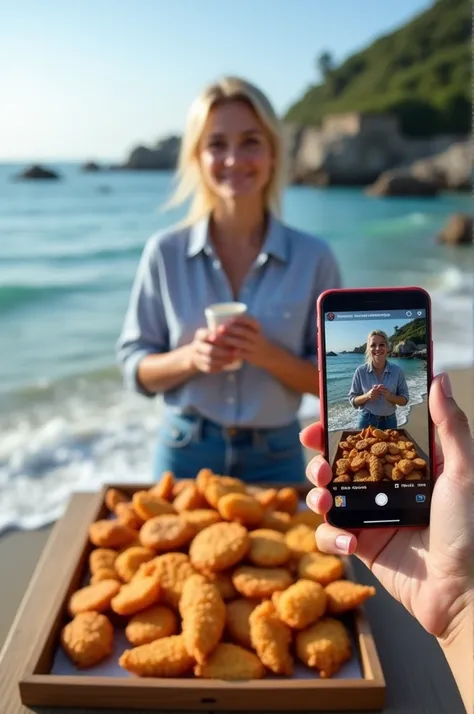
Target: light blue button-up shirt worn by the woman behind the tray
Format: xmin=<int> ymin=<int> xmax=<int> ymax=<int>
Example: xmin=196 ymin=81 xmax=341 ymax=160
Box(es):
xmin=117 ymin=211 xmax=340 ymax=428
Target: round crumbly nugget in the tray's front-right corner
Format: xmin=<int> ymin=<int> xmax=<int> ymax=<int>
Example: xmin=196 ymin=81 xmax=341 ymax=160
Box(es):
xmin=296 ymin=617 xmax=352 ymax=679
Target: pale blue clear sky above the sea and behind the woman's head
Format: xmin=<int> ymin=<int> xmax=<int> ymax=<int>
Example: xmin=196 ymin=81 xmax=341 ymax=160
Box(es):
xmin=0 ymin=0 xmax=432 ymax=161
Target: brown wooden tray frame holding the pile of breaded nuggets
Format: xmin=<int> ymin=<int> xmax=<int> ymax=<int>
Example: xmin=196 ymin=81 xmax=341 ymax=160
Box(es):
xmin=19 ymin=484 xmax=385 ymax=712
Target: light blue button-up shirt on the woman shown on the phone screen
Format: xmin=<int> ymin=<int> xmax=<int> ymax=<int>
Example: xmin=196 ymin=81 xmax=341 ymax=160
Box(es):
xmin=349 ymin=361 xmax=410 ymax=416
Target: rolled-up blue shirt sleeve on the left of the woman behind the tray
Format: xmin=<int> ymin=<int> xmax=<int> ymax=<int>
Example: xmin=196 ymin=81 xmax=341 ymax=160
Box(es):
xmin=116 ymin=237 xmax=169 ymax=397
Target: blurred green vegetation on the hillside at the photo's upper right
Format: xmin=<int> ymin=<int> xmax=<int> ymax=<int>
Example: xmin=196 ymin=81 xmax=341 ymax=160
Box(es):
xmin=285 ymin=0 xmax=471 ymax=136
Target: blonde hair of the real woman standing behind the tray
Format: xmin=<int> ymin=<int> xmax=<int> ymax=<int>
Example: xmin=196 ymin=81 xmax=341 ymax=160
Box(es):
xmin=166 ymin=77 xmax=284 ymax=225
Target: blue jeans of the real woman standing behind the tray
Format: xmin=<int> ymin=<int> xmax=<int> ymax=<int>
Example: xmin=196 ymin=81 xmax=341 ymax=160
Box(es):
xmin=153 ymin=414 xmax=305 ymax=483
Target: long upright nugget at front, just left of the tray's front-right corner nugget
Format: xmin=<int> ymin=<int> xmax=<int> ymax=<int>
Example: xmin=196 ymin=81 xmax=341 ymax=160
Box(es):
xmin=249 ymin=600 xmax=293 ymax=676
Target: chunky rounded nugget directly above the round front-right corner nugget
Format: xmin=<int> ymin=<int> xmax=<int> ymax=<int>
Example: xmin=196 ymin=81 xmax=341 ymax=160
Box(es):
xmin=273 ymin=580 xmax=326 ymax=630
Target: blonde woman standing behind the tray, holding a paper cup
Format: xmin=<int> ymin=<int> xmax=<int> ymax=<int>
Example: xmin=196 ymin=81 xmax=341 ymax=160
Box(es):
xmin=118 ymin=77 xmax=340 ymax=482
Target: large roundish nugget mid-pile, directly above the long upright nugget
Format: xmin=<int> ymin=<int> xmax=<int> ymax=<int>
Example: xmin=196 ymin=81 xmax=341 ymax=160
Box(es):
xmin=189 ymin=523 xmax=250 ymax=572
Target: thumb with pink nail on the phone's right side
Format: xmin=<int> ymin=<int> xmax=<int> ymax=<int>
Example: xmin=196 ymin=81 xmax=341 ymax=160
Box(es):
xmin=429 ymin=373 xmax=474 ymax=480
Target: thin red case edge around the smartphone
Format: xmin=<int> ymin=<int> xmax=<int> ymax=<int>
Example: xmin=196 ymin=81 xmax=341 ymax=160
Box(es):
xmin=316 ymin=285 xmax=436 ymax=530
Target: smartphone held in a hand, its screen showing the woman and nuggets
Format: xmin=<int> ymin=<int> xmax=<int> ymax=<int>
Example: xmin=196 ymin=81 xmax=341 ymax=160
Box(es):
xmin=317 ymin=287 xmax=435 ymax=529
